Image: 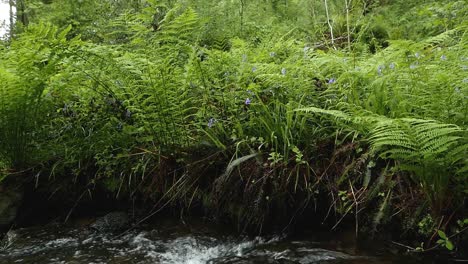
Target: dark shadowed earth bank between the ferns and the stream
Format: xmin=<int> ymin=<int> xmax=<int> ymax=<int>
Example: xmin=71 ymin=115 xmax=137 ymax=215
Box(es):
xmin=0 ymin=162 xmax=466 ymax=263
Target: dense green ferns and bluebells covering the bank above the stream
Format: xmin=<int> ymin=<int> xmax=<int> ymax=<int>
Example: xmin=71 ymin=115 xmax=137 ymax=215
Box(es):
xmin=0 ymin=0 xmax=468 ymax=255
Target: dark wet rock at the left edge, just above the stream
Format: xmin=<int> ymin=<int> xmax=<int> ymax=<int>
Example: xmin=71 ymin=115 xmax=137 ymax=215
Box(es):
xmin=0 ymin=186 xmax=23 ymax=231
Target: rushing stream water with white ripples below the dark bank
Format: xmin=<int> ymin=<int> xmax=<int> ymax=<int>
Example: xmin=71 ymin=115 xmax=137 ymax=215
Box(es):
xmin=0 ymin=218 xmax=456 ymax=264
